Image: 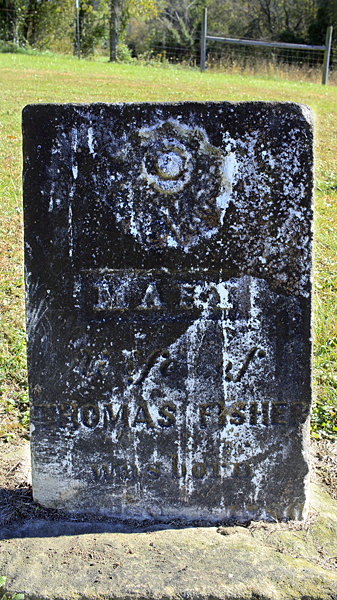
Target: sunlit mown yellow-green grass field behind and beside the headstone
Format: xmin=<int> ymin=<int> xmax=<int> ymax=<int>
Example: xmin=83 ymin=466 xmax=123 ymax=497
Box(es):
xmin=0 ymin=54 xmax=337 ymax=441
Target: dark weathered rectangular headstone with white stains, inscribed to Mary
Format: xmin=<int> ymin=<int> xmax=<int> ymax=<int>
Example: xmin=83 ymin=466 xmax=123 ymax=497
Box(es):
xmin=23 ymin=102 xmax=313 ymax=522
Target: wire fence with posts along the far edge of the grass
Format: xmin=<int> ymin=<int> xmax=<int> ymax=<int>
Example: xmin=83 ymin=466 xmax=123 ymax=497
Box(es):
xmin=0 ymin=8 xmax=337 ymax=85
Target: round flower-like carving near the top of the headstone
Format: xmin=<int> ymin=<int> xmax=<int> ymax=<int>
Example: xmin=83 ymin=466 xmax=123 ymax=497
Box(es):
xmin=116 ymin=120 xmax=234 ymax=252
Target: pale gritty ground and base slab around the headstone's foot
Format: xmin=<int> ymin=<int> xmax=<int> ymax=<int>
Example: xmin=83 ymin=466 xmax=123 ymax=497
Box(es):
xmin=0 ymin=444 xmax=337 ymax=600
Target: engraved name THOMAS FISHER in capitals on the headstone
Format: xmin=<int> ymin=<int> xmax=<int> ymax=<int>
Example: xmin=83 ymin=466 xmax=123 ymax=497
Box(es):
xmin=32 ymin=400 xmax=308 ymax=431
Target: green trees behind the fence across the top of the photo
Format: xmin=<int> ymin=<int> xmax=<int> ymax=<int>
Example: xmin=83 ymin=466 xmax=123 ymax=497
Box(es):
xmin=0 ymin=0 xmax=337 ymax=60
